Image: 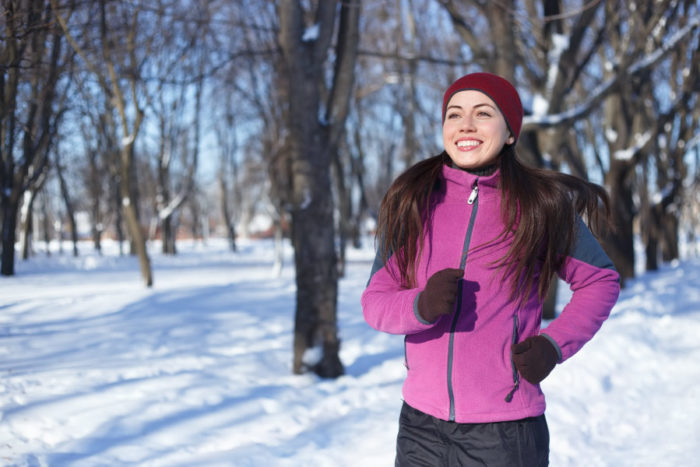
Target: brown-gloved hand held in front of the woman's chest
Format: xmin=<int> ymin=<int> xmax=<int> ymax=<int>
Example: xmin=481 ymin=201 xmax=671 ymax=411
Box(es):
xmin=418 ymin=268 xmax=464 ymax=323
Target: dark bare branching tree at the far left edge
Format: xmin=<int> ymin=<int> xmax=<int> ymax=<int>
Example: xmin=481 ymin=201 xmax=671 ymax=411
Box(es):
xmin=0 ymin=0 xmax=65 ymax=276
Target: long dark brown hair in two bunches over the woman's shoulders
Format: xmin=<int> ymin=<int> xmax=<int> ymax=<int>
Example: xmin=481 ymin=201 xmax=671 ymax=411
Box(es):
xmin=377 ymin=145 xmax=610 ymax=302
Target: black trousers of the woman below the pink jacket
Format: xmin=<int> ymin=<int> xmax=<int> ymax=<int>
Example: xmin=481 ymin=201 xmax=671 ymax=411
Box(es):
xmin=396 ymin=403 xmax=549 ymax=467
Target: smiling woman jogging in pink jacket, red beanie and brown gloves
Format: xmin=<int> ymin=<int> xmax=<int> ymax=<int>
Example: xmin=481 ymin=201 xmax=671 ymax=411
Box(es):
xmin=362 ymin=73 xmax=619 ymax=466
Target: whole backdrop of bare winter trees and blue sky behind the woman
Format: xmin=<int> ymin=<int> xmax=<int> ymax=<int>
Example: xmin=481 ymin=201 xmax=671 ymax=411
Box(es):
xmin=0 ymin=0 xmax=700 ymax=376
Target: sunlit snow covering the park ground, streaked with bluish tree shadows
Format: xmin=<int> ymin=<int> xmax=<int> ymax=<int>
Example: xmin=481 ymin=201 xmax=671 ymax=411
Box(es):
xmin=0 ymin=239 xmax=700 ymax=467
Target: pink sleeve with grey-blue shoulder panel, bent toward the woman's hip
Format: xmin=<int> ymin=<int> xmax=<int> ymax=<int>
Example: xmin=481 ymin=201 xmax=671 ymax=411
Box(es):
xmin=541 ymin=219 xmax=620 ymax=362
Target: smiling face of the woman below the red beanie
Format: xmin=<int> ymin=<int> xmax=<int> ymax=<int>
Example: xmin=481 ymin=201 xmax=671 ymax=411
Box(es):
xmin=442 ymin=90 xmax=515 ymax=169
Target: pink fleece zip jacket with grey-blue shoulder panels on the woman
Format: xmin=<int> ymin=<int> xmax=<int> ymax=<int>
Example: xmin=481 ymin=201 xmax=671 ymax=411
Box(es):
xmin=362 ymin=166 xmax=620 ymax=423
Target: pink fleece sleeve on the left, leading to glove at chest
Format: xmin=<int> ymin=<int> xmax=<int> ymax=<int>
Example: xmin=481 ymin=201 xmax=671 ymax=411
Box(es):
xmin=361 ymin=253 xmax=433 ymax=334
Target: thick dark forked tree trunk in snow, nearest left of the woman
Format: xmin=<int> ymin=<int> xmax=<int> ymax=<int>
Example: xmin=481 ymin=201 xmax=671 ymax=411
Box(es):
xmin=278 ymin=1 xmax=360 ymax=377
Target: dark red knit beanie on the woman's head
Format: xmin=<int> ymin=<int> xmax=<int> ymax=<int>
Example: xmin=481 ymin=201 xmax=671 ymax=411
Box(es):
xmin=442 ymin=73 xmax=523 ymax=141
